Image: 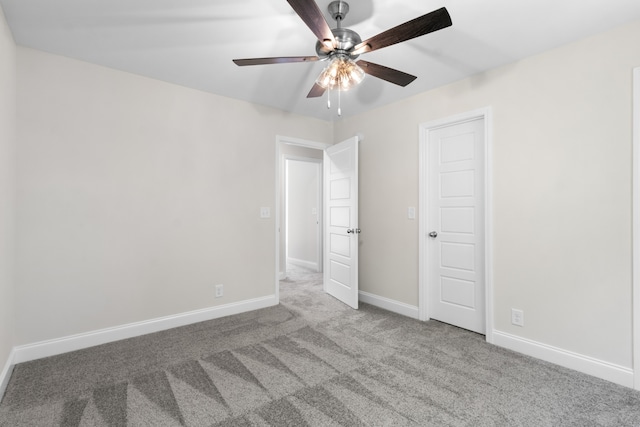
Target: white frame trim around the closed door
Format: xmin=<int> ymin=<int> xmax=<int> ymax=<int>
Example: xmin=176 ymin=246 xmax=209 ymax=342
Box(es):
xmin=418 ymin=107 xmax=493 ymax=343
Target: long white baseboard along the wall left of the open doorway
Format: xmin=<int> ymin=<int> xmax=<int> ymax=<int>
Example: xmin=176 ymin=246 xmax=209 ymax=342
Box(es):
xmin=13 ymin=295 xmax=277 ymax=364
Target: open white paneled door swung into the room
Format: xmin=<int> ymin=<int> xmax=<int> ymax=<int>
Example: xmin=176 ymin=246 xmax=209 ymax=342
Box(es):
xmin=324 ymin=137 xmax=360 ymax=309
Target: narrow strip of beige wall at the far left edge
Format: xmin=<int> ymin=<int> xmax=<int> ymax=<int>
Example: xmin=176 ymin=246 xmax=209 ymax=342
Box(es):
xmin=0 ymin=8 xmax=16 ymax=378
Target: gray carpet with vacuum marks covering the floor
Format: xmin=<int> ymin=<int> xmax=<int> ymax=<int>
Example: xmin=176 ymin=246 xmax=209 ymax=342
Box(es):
xmin=0 ymin=269 xmax=640 ymax=426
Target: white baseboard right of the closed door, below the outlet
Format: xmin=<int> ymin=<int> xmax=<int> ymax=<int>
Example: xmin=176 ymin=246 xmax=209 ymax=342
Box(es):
xmin=493 ymin=330 xmax=634 ymax=388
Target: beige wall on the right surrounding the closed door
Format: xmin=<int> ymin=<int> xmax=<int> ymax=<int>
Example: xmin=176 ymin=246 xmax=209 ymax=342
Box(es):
xmin=334 ymin=22 xmax=640 ymax=367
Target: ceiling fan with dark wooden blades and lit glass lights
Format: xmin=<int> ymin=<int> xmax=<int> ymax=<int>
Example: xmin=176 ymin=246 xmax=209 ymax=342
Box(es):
xmin=233 ymin=0 xmax=451 ymax=114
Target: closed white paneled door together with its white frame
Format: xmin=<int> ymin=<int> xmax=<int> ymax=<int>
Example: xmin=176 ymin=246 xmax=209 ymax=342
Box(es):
xmin=419 ymin=108 xmax=493 ymax=342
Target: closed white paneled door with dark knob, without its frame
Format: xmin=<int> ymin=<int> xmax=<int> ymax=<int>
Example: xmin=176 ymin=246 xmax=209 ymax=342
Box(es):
xmin=424 ymin=119 xmax=486 ymax=334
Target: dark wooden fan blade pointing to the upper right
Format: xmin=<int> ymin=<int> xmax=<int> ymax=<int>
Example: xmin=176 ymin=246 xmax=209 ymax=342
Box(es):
xmin=351 ymin=7 xmax=451 ymax=55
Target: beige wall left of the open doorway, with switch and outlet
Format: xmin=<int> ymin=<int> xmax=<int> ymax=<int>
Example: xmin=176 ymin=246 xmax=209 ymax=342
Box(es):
xmin=17 ymin=47 xmax=332 ymax=345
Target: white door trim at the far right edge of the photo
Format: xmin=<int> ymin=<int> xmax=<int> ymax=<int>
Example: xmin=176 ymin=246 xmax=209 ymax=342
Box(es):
xmin=631 ymin=67 xmax=640 ymax=390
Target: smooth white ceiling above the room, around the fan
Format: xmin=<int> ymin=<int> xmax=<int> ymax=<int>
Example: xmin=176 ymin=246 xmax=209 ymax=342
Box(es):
xmin=0 ymin=0 xmax=640 ymax=120
